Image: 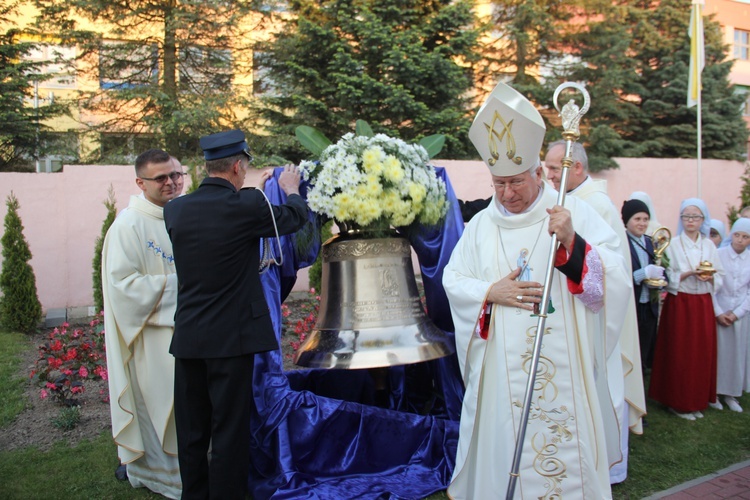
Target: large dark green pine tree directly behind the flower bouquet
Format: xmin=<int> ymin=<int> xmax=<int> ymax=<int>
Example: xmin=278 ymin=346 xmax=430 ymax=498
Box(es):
xmin=260 ymin=0 xmax=478 ymax=161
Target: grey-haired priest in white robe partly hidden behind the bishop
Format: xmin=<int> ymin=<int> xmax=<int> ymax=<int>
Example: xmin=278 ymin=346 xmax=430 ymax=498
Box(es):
xmin=544 ymin=141 xmax=646 ymax=484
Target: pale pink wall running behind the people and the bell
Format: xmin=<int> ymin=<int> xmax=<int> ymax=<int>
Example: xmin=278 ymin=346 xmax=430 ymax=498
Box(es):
xmin=0 ymin=158 xmax=744 ymax=310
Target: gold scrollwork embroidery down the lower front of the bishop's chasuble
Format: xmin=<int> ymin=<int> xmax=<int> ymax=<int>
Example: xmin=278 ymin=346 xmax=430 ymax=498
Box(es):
xmin=514 ymin=327 xmax=575 ymax=499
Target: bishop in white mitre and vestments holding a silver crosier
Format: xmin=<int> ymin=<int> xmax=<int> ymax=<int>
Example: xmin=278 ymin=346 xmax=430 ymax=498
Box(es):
xmin=443 ymin=84 xmax=632 ymax=499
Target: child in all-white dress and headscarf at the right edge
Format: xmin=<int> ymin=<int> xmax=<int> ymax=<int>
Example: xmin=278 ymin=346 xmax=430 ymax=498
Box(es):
xmin=712 ymin=219 xmax=750 ymax=412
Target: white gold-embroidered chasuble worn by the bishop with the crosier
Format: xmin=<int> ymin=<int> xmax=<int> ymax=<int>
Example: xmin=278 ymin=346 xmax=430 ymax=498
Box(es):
xmin=443 ymin=187 xmax=632 ymax=499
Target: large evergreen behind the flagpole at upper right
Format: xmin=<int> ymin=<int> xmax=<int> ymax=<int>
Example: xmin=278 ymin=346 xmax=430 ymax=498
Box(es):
xmin=547 ymin=0 xmax=748 ymax=171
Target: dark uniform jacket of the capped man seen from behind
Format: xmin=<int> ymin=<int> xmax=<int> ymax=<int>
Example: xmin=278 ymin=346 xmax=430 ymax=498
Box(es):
xmin=164 ymin=177 xmax=307 ymax=359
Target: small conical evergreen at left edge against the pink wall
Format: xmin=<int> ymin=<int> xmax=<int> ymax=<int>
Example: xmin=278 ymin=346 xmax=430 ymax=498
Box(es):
xmin=0 ymin=191 xmax=42 ymax=333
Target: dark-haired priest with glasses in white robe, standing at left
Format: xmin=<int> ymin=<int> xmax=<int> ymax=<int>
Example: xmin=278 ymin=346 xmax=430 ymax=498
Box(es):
xmin=102 ymin=149 xmax=182 ymax=498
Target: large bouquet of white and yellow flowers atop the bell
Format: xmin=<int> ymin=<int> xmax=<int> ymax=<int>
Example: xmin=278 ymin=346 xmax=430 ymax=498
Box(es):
xmin=300 ymin=133 xmax=448 ymax=226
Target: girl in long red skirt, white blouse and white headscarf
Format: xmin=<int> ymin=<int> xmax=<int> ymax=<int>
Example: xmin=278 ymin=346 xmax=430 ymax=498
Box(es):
xmin=649 ymin=198 xmax=724 ymax=420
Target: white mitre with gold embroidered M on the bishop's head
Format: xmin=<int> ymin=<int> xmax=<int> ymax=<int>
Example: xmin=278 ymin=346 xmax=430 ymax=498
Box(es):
xmin=469 ymin=83 xmax=546 ymax=177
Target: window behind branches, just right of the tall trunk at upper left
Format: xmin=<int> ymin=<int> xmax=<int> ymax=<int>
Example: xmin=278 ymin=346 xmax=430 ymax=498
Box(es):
xmin=178 ymin=47 xmax=234 ymax=93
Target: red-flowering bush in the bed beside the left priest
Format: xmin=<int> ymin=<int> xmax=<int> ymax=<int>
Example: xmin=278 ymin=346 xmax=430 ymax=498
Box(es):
xmin=31 ymin=314 xmax=107 ymax=405
